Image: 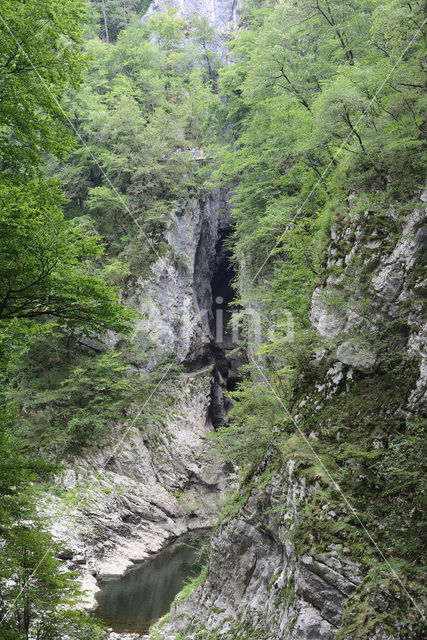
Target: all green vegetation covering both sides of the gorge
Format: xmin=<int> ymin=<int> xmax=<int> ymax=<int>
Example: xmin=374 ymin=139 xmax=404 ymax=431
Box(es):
xmin=0 ymin=0 xmax=426 ymax=640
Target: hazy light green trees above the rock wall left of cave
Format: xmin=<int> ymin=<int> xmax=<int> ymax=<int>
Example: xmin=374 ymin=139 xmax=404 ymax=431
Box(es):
xmin=48 ymin=10 xmax=218 ymax=276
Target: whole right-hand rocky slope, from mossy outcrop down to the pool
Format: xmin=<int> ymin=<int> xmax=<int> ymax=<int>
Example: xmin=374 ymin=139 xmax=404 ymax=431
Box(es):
xmin=152 ymin=194 xmax=427 ymax=640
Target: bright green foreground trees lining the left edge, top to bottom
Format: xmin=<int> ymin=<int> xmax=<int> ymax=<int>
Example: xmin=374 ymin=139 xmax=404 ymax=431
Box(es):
xmin=0 ymin=5 xmax=133 ymax=640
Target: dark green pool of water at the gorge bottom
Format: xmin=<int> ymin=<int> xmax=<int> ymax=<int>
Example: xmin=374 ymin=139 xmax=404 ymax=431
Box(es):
xmin=94 ymin=534 xmax=205 ymax=633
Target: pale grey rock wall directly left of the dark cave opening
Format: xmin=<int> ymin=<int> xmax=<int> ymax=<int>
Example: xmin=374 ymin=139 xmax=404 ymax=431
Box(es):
xmin=129 ymin=190 xmax=229 ymax=362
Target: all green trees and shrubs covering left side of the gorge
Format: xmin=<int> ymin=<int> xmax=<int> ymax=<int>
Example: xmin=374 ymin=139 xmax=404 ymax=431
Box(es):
xmin=0 ymin=0 xmax=219 ymax=640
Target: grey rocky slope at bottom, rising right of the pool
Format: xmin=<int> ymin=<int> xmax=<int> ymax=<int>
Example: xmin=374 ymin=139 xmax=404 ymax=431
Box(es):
xmin=166 ymin=459 xmax=362 ymax=640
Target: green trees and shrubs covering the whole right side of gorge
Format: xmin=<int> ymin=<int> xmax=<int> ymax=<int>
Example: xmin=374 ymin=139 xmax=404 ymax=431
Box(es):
xmin=210 ymin=0 xmax=426 ymax=638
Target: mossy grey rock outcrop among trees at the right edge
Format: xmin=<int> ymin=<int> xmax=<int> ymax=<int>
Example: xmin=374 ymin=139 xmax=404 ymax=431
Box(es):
xmin=311 ymin=195 xmax=427 ymax=388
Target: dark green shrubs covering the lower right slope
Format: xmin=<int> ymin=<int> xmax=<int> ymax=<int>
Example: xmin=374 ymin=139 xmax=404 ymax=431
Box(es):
xmin=270 ymin=361 xmax=426 ymax=638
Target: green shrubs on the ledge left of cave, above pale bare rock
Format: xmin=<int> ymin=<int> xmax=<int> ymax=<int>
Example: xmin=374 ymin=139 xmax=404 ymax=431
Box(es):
xmin=4 ymin=335 xmax=180 ymax=457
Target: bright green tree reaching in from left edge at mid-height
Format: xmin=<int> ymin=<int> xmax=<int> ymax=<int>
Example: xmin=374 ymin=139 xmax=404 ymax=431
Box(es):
xmin=0 ymin=180 xmax=133 ymax=334
